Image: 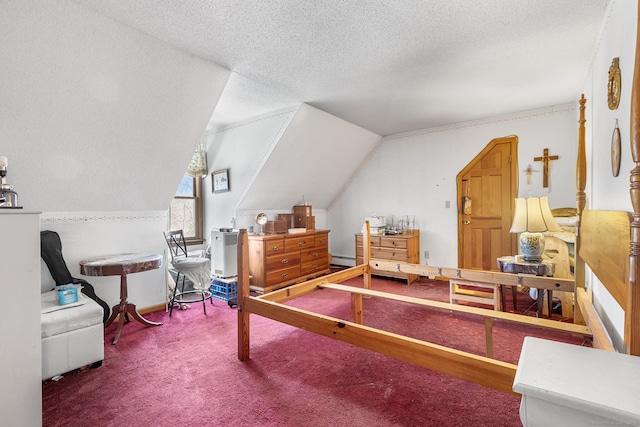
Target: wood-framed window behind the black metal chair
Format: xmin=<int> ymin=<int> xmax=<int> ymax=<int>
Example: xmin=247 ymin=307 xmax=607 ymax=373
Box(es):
xmin=169 ymin=174 xmax=204 ymax=245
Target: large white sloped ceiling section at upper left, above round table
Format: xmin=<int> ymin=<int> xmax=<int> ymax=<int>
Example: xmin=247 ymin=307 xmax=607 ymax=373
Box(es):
xmin=0 ymin=0 xmax=229 ymax=212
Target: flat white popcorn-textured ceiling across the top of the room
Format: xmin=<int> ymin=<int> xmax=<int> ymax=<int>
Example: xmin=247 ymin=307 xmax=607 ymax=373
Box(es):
xmin=69 ymin=0 xmax=609 ymax=135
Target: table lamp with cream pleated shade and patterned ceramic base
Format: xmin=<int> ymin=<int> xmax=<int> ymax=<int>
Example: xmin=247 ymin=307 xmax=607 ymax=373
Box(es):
xmin=509 ymin=197 xmax=560 ymax=262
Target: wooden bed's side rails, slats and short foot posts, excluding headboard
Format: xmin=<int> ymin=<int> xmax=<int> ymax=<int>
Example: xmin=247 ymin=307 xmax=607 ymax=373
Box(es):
xmin=238 ymin=230 xmax=593 ymax=394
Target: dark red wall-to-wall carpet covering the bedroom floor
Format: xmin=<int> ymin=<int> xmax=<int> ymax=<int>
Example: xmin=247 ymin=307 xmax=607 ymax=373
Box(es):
xmin=43 ymin=279 xmax=580 ymax=427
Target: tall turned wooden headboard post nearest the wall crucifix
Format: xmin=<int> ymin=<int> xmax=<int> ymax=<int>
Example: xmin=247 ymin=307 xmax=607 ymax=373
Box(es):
xmin=573 ymin=94 xmax=587 ymax=324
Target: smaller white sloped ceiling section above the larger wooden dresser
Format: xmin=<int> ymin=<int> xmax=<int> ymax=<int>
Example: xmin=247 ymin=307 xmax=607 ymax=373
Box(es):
xmin=239 ymin=104 xmax=380 ymax=209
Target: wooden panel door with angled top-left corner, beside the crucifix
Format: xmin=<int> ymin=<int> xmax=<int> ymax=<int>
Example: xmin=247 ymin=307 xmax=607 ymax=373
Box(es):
xmin=457 ymin=136 xmax=518 ymax=270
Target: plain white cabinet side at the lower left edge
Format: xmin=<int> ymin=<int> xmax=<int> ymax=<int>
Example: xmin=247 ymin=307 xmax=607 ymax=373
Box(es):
xmin=0 ymin=209 xmax=42 ymax=426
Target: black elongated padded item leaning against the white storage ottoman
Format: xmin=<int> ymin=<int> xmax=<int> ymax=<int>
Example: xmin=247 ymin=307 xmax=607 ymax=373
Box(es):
xmin=40 ymin=230 xmax=111 ymax=323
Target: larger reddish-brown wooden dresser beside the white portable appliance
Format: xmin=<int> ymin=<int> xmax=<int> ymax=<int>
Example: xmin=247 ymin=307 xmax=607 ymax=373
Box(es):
xmin=249 ymin=230 xmax=330 ymax=292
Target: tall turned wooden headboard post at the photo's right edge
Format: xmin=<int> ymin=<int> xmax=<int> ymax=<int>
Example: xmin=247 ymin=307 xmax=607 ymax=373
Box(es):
xmin=623 ymin=0 xmax=640 ymax=356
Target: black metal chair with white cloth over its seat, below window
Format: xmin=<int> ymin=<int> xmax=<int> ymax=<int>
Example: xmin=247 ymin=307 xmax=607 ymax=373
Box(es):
xmin=164 ymin=230 xmax=213 ymax=317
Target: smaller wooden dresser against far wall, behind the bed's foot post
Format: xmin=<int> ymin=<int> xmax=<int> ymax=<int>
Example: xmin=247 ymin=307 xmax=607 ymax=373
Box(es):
xmin=356 ymin=230 xmax=420 ymax=284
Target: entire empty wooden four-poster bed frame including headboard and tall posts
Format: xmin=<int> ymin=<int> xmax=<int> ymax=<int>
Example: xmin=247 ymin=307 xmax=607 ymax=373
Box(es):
xmin=238 ymin=7 xmax=640 ymax=394
